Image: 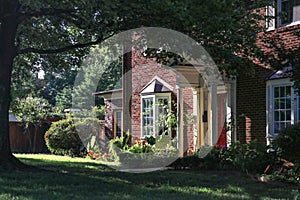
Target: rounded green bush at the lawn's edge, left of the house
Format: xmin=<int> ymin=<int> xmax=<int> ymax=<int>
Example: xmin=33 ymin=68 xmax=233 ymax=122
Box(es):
xmin=44 ymin=118 xmax=83 ymax=156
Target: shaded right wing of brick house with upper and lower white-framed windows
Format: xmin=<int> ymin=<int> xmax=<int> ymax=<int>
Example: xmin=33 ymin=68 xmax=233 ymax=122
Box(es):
xmin=236 ymin=0 xmax=300 ymax=144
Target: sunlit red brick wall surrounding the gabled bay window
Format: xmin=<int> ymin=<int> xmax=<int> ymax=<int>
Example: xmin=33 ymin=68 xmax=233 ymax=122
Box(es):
xmin=131 ymin=51 xmax=194 ymax=152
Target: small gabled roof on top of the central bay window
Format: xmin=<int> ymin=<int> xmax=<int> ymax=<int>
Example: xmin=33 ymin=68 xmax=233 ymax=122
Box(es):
xmin=141 ymin=76 xmax=173 ymax=94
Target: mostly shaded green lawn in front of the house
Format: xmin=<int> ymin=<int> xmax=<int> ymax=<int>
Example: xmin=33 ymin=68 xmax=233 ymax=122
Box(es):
xmin=0 ymin=154 xmax=299 ymax=200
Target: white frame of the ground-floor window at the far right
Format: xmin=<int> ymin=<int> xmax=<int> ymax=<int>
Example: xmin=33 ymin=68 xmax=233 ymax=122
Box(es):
xmin=266 ymin=78 xmax=300 ymax=144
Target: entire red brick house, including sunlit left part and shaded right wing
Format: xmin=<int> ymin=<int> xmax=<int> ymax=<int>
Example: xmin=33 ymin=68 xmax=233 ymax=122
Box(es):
xmin=95 ymin=0 xmax=300 ymax=154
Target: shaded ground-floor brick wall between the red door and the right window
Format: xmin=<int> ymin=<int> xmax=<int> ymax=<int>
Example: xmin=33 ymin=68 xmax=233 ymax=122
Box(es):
xmin=236 ymin=66 xmax=272 ymax=143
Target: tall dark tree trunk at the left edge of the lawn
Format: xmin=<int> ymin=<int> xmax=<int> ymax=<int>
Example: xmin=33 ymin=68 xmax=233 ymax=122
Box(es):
xmin=0 ymin=0 xmax=25 ymax=170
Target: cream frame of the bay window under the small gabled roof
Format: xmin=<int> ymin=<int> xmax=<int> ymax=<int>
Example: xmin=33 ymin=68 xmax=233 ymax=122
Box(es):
xmin=141 ymin=93 xmax=171 ymax=138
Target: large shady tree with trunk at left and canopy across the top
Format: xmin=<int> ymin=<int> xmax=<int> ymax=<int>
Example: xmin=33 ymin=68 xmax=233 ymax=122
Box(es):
xmin=0 ymin=0 xmax=276 ymax=169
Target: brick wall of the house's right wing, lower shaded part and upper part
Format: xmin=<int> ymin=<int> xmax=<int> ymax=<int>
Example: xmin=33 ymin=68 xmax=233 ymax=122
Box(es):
xmin=236 ymin=24 xmax=300 ymax=143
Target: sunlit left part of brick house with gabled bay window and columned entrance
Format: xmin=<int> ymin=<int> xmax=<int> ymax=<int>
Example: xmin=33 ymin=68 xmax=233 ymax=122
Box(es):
xmin=95 ymin=48 xmax=235 ymax=155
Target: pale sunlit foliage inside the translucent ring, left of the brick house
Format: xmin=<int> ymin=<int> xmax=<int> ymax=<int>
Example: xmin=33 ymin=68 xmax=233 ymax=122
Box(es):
xmin=73 ymin=46 xmax=122 ymax=109
